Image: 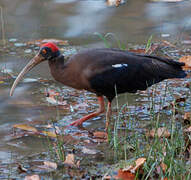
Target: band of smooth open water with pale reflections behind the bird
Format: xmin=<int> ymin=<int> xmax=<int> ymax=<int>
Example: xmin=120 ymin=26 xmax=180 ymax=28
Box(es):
xmin=1 ymin=0 xmax=191 ymax=45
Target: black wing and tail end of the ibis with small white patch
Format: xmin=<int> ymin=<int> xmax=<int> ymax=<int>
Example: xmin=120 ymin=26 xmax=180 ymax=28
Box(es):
xmin=89 ymin=49 xmax=186 ymax=101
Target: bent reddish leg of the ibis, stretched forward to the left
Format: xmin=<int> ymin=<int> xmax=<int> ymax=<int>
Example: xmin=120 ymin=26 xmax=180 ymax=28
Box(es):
xmin=70 ymin=96 xmax=105 ymax=126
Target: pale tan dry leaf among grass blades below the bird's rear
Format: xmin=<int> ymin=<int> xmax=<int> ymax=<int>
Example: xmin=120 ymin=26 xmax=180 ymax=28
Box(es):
xmin=146 ymin=127 xmax=170 ymax=138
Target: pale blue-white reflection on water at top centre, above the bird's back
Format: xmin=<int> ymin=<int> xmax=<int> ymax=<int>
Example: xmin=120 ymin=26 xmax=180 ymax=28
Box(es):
xmin=65 ymin=1 xmax=111 ymax=37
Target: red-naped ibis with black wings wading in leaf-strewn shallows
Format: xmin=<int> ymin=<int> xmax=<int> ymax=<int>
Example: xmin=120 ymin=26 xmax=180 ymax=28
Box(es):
xmin=10 ymin=43 xmax=186 ymax=128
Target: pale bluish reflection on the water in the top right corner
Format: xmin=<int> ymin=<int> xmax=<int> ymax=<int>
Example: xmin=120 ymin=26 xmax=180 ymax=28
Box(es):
xmin=145 ymin=2 xmax=191 ymax=34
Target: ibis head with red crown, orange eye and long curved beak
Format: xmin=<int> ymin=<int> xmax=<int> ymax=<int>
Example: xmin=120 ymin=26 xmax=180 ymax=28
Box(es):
xmin=10 ymin=42 xmax=60 ymax=96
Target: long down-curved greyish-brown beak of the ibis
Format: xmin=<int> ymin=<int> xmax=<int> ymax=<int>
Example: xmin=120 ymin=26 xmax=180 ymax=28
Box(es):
xmin=10 ymin=54 xmax=45 ymax=96
